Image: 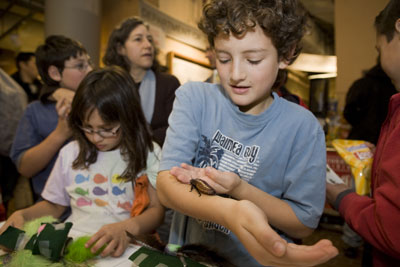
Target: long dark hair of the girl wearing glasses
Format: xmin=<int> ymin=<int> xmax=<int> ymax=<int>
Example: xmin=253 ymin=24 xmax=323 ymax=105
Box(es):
xmin=68 ymin=66 xmax=153 ymax=180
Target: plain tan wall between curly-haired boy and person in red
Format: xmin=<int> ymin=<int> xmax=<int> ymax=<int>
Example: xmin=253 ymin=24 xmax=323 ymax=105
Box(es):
xmin=335 ymin=0 xmax=389 ymax=108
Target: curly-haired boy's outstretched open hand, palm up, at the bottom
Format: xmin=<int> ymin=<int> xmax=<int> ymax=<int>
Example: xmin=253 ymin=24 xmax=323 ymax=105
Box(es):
xmin=225 ymin=200 xmax=338 ymax=266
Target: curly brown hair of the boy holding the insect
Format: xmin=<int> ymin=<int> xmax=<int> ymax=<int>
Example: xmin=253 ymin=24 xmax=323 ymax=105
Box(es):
xmin=198 ymin=0 xmax=307 ymax=64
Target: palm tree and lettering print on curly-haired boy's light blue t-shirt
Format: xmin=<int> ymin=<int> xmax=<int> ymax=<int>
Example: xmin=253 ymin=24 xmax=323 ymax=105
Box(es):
xmin=194 ymin=130 xmax=260 ymax=234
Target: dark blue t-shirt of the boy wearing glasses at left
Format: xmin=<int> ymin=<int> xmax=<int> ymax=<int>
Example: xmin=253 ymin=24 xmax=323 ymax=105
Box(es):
xmin=10 ymin=101 xmax=64 ymax=196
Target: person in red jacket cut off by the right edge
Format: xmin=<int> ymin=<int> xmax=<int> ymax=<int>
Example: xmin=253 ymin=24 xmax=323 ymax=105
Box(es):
xmin=326 ymin=0 xmax=400 ymax=266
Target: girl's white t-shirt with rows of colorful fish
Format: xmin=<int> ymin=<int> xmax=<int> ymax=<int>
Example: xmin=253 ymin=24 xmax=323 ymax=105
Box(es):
xmin=42 ymin=141 xmax=161 ymax=234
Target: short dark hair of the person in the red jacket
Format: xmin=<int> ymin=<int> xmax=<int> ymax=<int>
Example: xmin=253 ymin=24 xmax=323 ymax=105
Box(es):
xmin=375 ymin=0 xmax=400 ymax=42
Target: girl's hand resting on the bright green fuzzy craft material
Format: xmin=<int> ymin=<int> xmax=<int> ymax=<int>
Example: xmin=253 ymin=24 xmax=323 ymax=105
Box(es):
xmin=85 ymin=221 xmax=130 ymax=257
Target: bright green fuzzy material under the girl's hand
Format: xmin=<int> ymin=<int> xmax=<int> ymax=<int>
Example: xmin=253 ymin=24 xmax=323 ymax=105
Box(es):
xmin=64 ymin=236 xmax=106 ymax=263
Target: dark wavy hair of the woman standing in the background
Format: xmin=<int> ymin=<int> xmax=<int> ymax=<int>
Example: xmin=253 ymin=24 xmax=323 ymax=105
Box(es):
xmin=103 ymin=17 xmax=160 ymax=72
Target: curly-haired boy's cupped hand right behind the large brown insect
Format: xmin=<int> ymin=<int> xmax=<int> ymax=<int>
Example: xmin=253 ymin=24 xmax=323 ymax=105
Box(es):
xmin=170 ymin=163 xmax=242 ymax=194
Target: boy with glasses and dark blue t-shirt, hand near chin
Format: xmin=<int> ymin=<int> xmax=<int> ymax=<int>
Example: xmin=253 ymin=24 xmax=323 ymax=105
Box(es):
xmin=10 ymin=35 xmax=92 ymax=200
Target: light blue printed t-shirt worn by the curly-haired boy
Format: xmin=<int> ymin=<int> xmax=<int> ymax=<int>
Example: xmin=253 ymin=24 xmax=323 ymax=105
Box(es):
xmin=160 ymin=82 xmax=326 ymax=266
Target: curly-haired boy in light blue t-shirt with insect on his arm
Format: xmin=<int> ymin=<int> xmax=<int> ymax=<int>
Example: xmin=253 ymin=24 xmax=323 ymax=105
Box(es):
xmin=157 ymin=0 xmax=337 ymax=266
